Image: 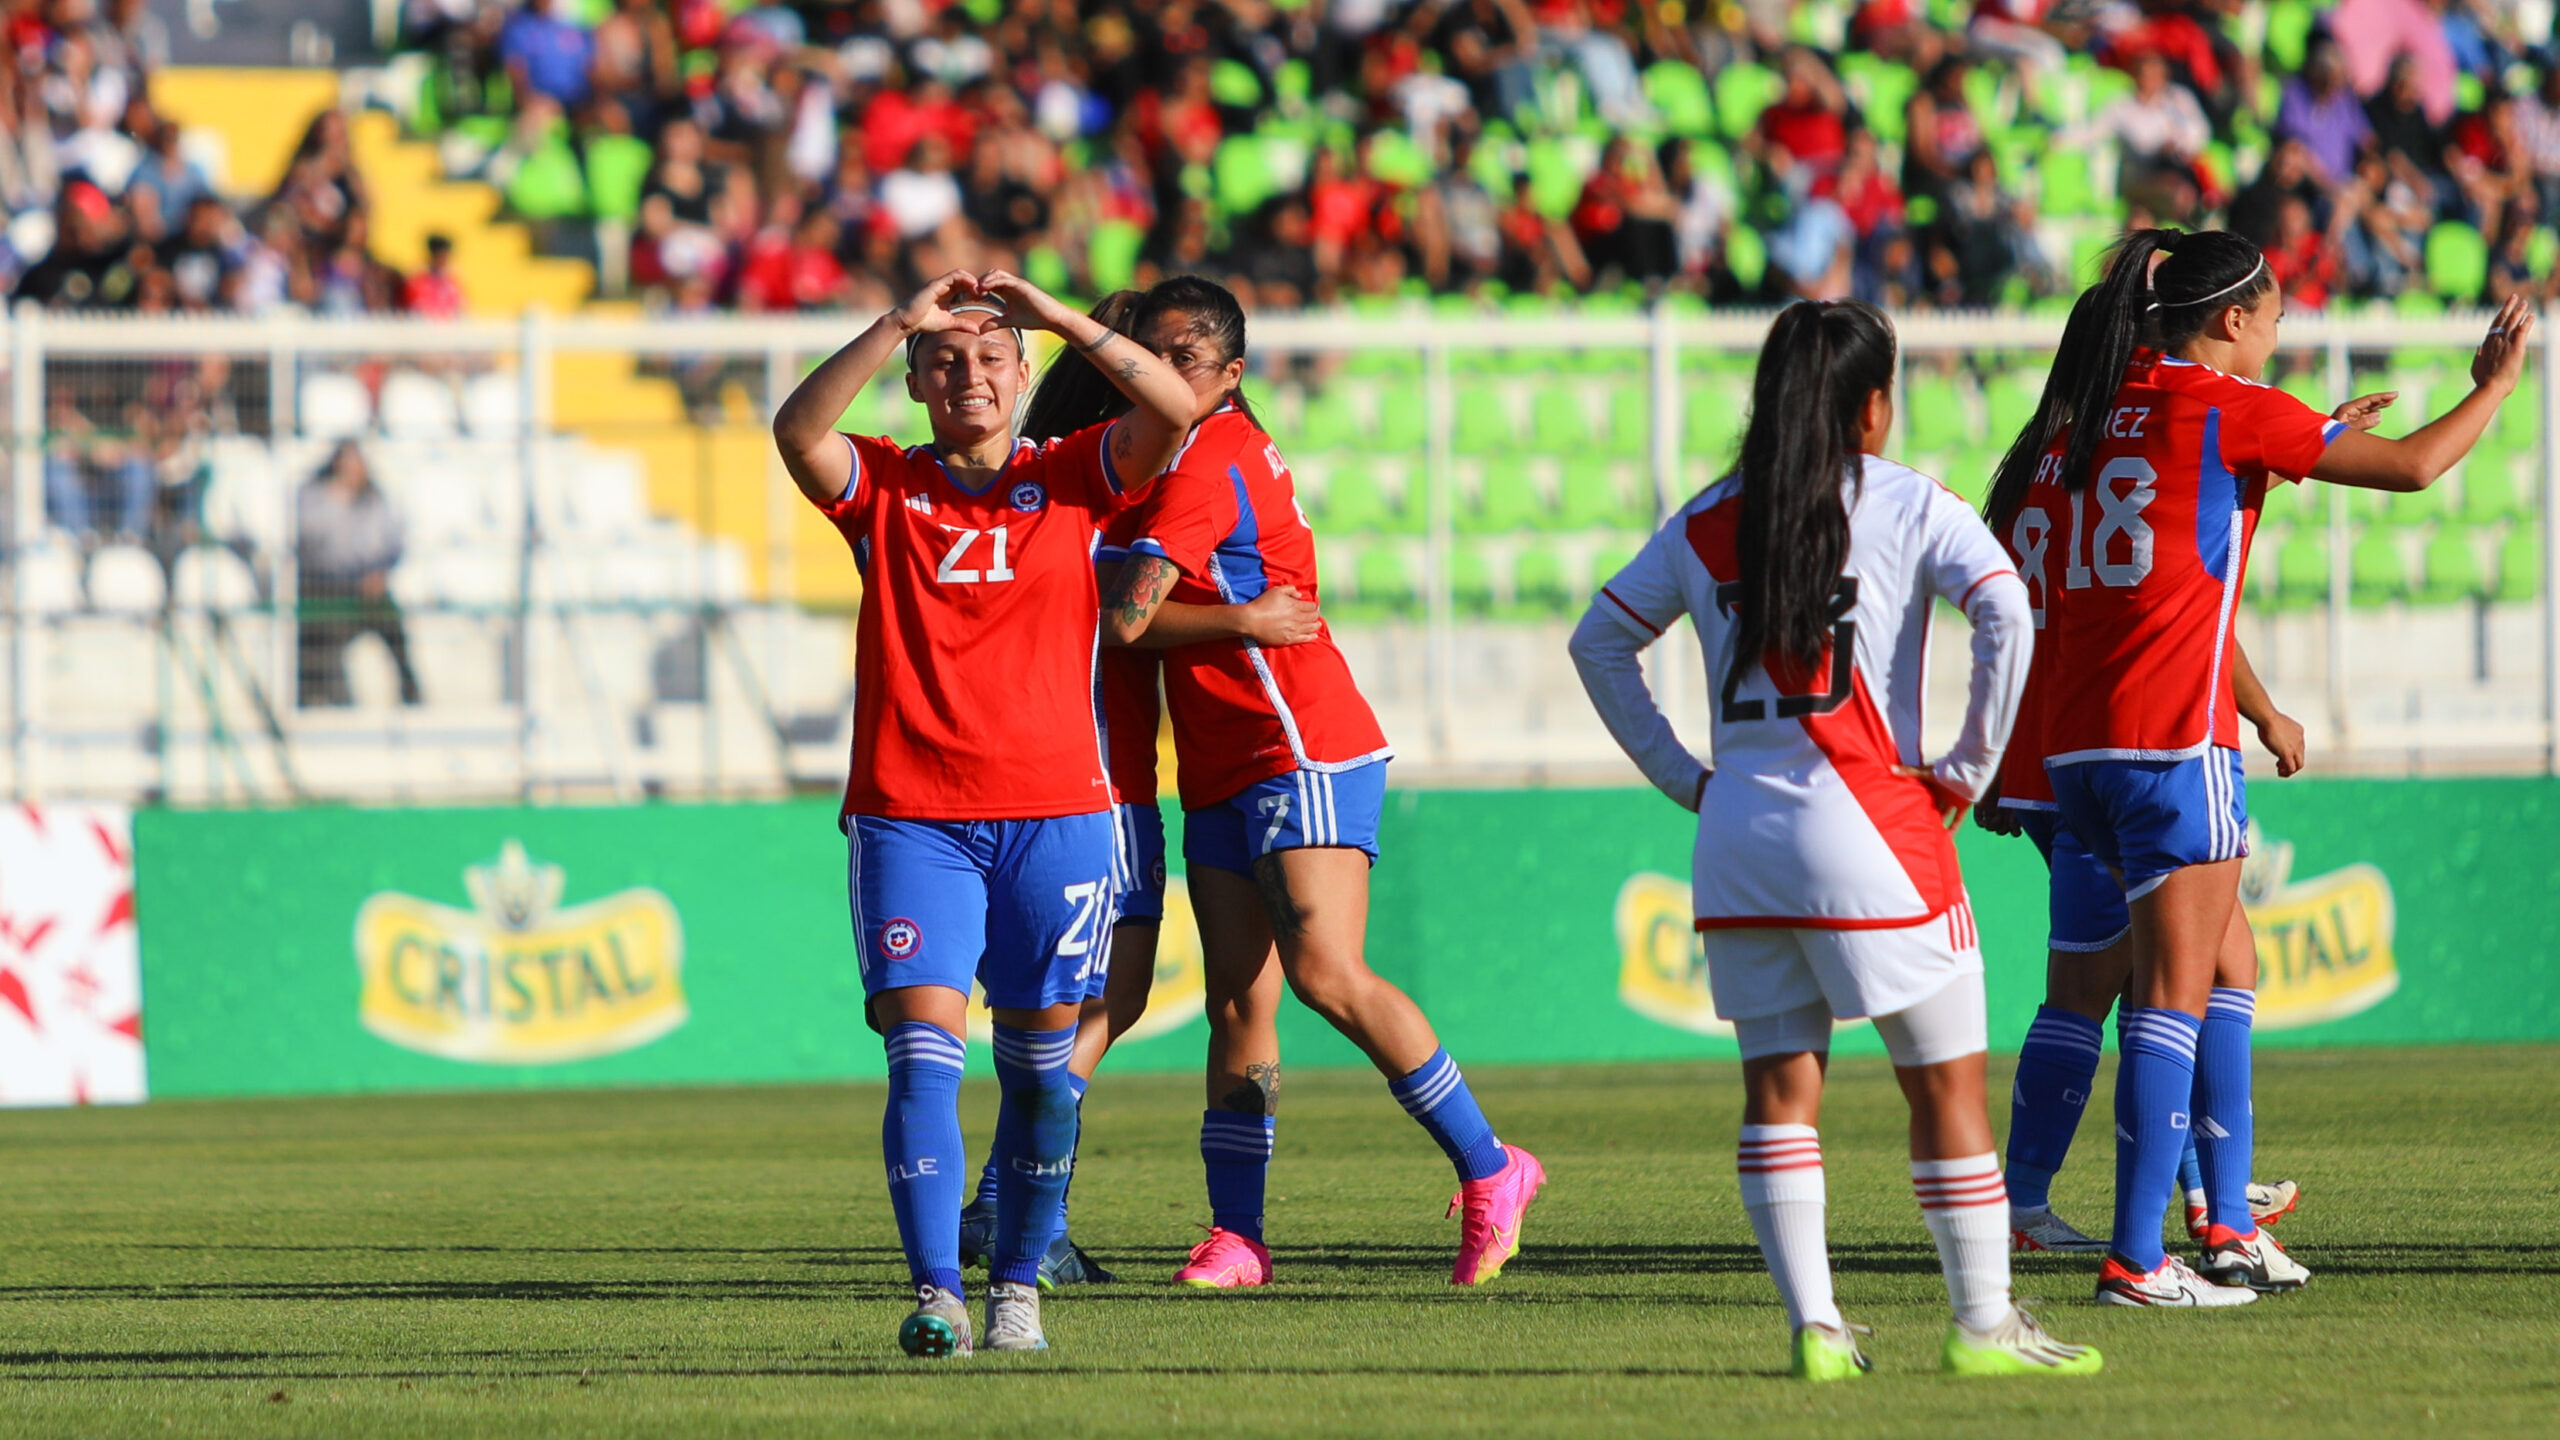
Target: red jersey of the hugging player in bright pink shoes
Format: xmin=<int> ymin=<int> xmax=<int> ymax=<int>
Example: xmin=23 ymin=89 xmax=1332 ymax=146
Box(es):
xmin=1129 ymin=405 xmax=1393 ymax=810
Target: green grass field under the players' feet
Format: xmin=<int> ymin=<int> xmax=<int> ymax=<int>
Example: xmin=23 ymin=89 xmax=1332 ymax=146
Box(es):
xmin=0 ymin=1048 xmax=2560 ymax=1440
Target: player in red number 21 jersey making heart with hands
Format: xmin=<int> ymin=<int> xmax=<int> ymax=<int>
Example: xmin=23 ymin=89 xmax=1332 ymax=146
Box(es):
xmin=773 ymin=272 xmax=1190 ymax=1355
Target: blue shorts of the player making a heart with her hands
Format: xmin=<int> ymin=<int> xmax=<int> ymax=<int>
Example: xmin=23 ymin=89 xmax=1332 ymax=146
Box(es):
xmin=845 ymin=810 xmax=1119 ymax=1010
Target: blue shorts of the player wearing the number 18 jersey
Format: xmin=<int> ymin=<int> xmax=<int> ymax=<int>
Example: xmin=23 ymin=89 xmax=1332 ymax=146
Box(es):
xmin=2045 ymin=746 xmax=2248 ymax=899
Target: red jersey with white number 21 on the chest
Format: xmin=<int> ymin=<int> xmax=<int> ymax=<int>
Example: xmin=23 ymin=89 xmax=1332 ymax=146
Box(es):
xmin=819 ymin=425 xmax=1129 ymax=820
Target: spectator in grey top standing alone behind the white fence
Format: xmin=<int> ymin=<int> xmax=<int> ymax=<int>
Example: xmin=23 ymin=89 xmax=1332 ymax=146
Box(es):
xmin=294 ymin=441 xmax=420 ymax=707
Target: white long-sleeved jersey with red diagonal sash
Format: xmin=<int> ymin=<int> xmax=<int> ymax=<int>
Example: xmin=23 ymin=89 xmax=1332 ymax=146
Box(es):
xmin=1572 ymin=456 xmax=2033 ymax=930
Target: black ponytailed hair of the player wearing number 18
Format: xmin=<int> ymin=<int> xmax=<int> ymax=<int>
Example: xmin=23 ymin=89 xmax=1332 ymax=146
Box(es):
xmin=1981 ymin=231 xmax=2276 ymax=509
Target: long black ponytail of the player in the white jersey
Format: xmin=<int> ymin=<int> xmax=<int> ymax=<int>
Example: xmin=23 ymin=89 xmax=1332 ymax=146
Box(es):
xmin=1736 ymin=300 xmax=1894 ymax=669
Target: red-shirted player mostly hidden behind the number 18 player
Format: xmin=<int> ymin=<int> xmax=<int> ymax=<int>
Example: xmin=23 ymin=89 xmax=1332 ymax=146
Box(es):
xmin=1976 ymin=290 xmax=2324 ymax=1256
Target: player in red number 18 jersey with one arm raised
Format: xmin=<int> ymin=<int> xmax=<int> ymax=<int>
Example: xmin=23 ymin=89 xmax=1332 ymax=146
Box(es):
xmin=2012 ymin=231 xmax=2534 ymax=1307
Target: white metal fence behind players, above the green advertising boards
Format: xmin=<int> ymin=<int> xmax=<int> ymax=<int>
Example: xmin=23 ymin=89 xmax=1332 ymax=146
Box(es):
xmin=0 ymin=310 xmax=2560 ymax=805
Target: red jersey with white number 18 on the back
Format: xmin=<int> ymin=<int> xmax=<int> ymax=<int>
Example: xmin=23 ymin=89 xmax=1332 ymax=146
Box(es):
xmin=2010 ymin=351 xmax=2345 ymax=764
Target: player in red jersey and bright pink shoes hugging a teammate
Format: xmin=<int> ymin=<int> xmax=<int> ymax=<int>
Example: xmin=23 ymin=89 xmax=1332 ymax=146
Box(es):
xmin=1080 ymin=277 xmax=1546 ymax=1289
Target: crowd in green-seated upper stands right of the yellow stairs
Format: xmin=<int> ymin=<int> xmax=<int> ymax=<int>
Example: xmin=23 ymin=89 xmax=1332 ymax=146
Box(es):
xmin=407 ymin=0 xmax=2560 ymax=310
